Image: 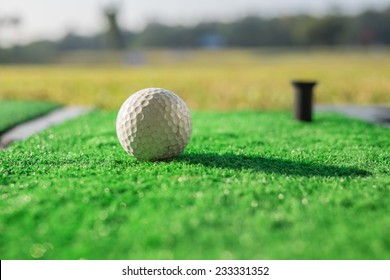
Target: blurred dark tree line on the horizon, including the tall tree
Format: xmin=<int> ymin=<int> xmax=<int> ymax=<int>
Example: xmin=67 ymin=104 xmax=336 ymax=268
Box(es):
xmin=0 ymin=4 xmax=390 ymax=63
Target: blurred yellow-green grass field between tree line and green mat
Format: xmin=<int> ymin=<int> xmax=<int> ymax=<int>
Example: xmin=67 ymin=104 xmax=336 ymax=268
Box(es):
xmin=0 ymin=49 xmax=390 ymax=108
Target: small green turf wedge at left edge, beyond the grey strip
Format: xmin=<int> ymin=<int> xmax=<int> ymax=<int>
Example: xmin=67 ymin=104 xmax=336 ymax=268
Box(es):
xmin=0 ymin=100 xmax=59 ymax=135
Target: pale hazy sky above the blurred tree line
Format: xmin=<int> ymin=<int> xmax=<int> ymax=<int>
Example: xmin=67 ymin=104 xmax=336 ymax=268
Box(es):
xmin=0 ymin=0 xmax=390 ymax=46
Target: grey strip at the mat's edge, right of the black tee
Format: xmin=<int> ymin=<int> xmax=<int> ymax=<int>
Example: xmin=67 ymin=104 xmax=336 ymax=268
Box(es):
xmin=315 ymin=105 xmax=390 ymax=127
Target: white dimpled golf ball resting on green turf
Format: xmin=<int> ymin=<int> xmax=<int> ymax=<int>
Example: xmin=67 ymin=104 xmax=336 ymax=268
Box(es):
xmin=116 ymin=88 xmax=192 ymax=160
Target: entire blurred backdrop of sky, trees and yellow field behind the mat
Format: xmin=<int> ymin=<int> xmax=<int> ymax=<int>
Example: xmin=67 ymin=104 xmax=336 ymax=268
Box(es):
xmin=0 ymin=0 xmax=390 ymax=109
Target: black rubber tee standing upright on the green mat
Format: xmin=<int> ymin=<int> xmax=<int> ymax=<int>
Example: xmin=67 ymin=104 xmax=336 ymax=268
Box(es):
xmin=292 ymin=81 xmax=317 ymax=122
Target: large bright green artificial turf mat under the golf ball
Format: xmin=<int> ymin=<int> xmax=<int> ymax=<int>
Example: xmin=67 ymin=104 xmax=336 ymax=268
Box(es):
xmin=0 ymin=112 xmax=390 ymax=259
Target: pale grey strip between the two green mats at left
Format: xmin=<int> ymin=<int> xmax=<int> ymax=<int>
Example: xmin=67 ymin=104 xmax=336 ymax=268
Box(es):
xmin=0 ymin=106 xmax=92 ymax=149
